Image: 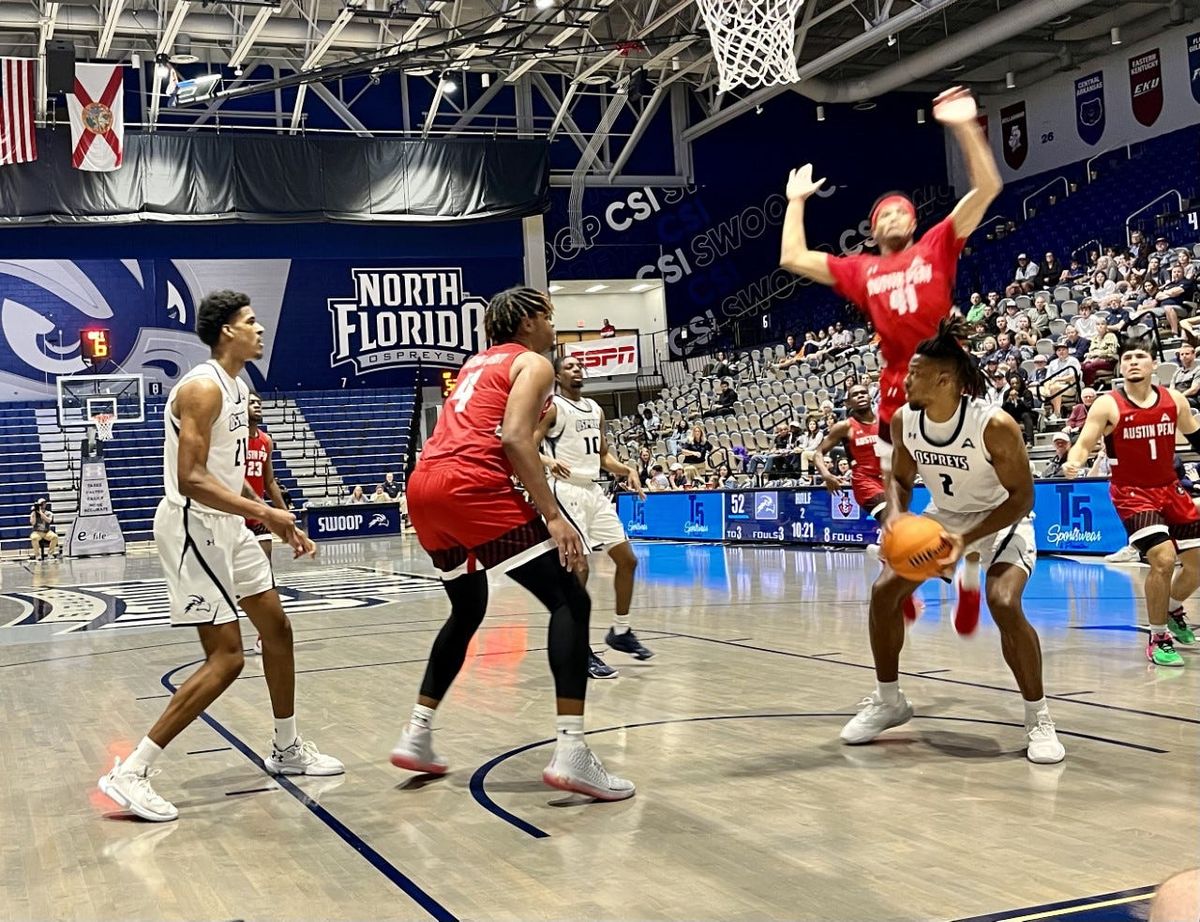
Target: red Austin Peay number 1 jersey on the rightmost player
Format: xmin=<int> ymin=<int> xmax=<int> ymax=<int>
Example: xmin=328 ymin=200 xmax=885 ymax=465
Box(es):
xmin=1104 ymin=385 xmax=1180 ymax=487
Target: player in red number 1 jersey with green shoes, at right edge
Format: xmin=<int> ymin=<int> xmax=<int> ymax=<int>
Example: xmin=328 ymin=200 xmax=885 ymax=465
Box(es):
xmin=1063 ymin=339 xmax=1200 ymax=666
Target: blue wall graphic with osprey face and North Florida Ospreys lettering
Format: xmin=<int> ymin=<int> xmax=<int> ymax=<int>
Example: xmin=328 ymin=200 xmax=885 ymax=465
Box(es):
xmin=0 ymin=258 xmax=522 ymax=400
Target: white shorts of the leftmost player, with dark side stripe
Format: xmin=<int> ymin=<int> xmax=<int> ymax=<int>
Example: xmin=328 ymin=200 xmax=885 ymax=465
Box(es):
xmin=154 ymin=499 xmax=275 ymax=627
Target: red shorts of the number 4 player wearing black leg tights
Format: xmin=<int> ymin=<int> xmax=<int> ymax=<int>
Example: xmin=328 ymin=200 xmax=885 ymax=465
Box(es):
xmin=408 ymin=465 xmax=554 ymax=580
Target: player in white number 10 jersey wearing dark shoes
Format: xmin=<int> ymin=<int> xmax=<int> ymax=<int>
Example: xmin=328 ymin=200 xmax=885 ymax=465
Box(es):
xmin=536 ymin=355 xmax=654 ymax=678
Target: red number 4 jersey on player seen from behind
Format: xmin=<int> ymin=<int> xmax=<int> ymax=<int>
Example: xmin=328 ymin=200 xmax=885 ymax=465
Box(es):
xmin=418 ymin=342 xmax=540 ymax=486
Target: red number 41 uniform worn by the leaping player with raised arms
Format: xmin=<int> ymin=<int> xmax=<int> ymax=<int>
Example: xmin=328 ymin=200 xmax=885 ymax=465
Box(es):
xmin=828 ymin=217 xmax=966 ymax=425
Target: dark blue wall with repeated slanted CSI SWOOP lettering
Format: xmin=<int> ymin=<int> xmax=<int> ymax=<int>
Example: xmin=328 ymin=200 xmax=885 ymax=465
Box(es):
xmin=546 ymin=94 xmax=949 ymax=355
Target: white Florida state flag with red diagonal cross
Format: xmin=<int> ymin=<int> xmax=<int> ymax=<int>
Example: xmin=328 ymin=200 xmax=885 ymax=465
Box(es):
xmin=67 ymin=64 xmax=125 ymax=173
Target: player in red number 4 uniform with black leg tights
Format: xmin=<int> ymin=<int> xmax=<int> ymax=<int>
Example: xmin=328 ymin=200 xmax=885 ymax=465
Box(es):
xmin=391 ymin=288 xmax=634 ymax=801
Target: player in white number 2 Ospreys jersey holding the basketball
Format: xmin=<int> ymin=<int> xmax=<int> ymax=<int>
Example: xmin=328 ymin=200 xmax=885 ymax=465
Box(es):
xmin=841 ymin=319 xmax=1064 ymax=762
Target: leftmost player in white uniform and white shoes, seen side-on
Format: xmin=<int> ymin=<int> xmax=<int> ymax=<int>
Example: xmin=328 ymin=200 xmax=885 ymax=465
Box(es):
xmin=100 ymin=292 xmax=344 ymax=822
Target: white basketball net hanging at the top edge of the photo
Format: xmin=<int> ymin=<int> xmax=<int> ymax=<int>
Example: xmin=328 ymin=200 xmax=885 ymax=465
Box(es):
xmin=700 ymin=0 xmax=804 ymax=92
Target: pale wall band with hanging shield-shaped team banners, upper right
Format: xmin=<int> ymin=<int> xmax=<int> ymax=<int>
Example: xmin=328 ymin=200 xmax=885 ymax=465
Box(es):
xmin=969 ymin=24 xmax=1200 ymax=187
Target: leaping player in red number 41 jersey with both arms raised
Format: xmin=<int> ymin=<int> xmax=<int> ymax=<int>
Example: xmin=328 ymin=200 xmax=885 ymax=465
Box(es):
xmin=779 ymin=86 xmax=1003 ymax=628
